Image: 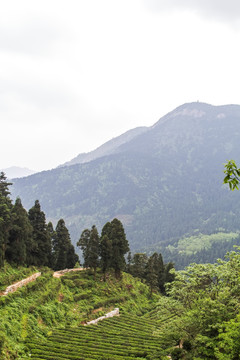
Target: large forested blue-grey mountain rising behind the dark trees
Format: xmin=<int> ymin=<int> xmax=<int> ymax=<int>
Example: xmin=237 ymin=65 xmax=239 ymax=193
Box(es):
xmin=12 ymin=102 xmax=240 ymax=262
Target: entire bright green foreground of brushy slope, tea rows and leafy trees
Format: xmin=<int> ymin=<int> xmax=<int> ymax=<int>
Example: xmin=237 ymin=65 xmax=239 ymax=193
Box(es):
xmin=0 ymin=248 xmax=240 ymax=360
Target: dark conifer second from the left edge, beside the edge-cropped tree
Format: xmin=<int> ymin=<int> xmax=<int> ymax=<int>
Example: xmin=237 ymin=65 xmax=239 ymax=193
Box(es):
xmin=6 ymin=198 xmax=33 ymax=265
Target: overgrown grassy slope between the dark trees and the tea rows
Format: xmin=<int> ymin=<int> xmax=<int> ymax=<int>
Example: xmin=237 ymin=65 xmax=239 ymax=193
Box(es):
xmin=0 ymin=269 xmax=158 ymax=360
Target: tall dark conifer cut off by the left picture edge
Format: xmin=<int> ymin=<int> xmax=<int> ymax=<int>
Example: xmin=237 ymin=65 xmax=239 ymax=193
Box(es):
xmin=0 ymin=172 xmax=12 ymax=268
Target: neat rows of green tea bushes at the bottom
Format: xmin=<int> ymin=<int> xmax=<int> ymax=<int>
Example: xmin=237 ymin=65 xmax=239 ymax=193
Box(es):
xmin=27 ymin=314 xmax=164 ymax=360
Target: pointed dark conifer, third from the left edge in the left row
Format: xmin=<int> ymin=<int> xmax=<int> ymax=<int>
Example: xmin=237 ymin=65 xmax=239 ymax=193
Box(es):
xmin=27 ymin=200 xmax=52 ymax=266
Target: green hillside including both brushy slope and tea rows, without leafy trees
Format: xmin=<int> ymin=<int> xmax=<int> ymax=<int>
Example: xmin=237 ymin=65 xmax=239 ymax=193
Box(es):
xmin=0 ymin=265 xmax=160 ymax=360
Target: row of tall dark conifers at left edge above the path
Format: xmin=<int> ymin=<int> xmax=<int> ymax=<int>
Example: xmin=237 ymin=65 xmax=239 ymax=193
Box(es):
xmin=0 ymin=172 xmax=79 ymax=270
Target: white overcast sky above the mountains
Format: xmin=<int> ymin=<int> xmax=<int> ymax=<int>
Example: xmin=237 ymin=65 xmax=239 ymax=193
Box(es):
xmin=0 ymin=0 xmax=240 ymax=171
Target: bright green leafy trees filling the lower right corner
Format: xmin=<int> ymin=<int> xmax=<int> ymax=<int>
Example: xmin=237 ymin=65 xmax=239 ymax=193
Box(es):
xmin=142 ymin=248 xmax=240 ymax=360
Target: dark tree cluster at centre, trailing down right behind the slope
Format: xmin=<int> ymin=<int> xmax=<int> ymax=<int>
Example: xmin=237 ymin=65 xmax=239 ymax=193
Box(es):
xmin=77 ymin=218 xmax=174 ymax=294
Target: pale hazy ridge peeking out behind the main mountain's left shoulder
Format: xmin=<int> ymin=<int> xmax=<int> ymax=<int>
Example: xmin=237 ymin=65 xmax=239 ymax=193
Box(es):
xmin=60 ymin=126 xmax=148 ymax=167
